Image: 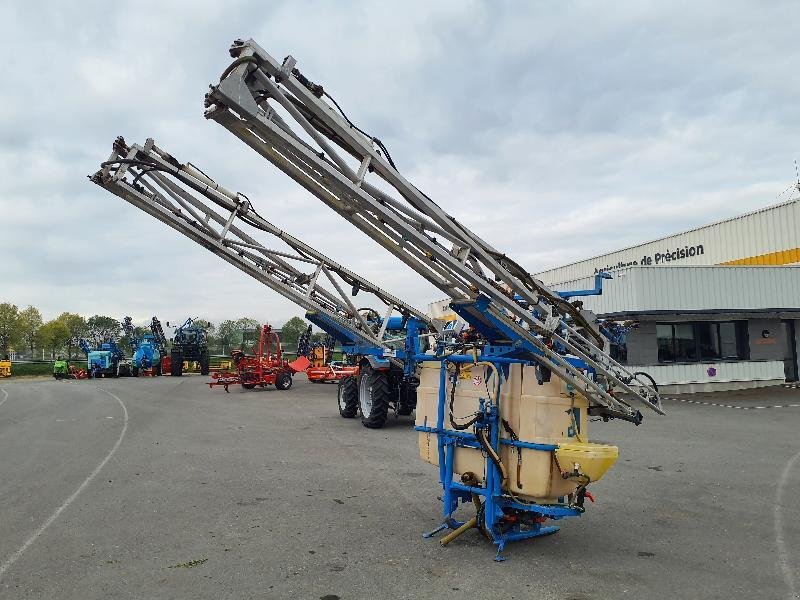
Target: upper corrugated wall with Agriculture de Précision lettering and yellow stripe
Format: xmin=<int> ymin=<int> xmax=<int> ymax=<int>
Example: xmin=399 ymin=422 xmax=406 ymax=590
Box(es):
xmin=536 ymin=195 xmax=800 ymax=285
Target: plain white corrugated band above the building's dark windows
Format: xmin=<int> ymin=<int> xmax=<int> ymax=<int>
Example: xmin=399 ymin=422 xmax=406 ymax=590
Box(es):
xmin=553 ymin=266 xmax=800 ymax=315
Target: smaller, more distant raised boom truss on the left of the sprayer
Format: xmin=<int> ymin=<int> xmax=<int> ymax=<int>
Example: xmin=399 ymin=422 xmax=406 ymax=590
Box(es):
xmin=90 ymin=137 xmax=430 ymax=347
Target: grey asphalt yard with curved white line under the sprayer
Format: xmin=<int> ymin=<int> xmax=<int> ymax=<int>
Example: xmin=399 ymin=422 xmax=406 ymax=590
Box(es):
xmin=0 ymin=375 xmax=800 ymax=600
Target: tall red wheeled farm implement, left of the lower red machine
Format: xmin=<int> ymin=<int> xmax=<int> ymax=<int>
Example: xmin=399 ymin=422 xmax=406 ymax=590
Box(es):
xmin=208 ymin=325 xmax=309 ymax=392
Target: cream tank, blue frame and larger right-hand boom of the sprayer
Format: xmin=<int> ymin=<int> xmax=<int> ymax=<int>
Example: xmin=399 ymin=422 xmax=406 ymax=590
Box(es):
xmin=198 ymin=40 xmax=664 ymax=560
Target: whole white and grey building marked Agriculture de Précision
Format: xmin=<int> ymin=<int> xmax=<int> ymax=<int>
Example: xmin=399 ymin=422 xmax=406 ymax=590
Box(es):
xmin=537 ymin=193 xmax=800 ymax=392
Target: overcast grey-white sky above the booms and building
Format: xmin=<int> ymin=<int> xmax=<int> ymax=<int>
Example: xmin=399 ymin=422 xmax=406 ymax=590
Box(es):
xmin=0 ymin=0 xmax=800 ymax=324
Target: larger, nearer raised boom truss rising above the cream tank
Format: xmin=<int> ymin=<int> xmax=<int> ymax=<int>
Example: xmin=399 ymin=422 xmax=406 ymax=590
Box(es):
xmin=205 ymin=40 xmax=664 ymax=423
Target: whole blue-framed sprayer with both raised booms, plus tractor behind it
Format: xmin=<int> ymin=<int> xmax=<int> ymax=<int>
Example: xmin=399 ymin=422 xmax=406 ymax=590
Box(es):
xmin=92 ymin=40 xmax=664 ymax=560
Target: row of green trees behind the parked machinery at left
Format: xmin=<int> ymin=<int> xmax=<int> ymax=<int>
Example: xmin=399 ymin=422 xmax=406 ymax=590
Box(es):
xmin=0 ymin=302 xmax=318 ymax=359
